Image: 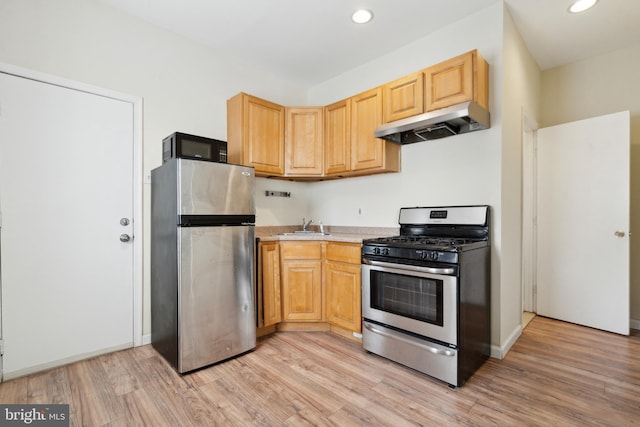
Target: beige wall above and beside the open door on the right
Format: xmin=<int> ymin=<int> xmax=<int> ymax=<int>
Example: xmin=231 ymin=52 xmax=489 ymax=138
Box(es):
xmin=541 ymin=45 xmax=640 ymax=328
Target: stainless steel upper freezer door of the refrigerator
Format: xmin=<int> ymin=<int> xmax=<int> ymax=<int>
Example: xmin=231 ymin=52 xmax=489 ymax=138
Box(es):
xmin=176 ymin=159 xmax=255 ymax=215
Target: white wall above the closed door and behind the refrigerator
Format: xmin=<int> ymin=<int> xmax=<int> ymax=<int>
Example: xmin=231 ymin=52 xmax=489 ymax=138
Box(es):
xmin=0 ymin=0 xmax=308 ymax=334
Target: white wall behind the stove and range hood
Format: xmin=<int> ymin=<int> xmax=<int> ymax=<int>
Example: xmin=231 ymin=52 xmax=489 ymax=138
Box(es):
xmin=308 ymin=3 xmax=510 ymax=346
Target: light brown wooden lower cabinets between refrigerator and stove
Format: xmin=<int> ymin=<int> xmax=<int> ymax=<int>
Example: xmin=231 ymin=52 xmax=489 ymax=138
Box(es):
xmin=258 ymin=241 xmax=362 ymax=333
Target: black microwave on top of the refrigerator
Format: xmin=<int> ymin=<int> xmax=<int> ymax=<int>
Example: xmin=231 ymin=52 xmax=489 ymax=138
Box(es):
xmin=162 ymin=132 xmax=227 ymax=163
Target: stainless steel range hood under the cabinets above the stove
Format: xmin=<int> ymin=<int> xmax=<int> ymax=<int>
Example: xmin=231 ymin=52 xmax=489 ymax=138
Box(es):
xmin=374 ymin=101 xmax=490 ymax=144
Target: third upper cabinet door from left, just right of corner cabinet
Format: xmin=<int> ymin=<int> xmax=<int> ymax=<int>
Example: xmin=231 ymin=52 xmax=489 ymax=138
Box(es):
xmin=324 ymin=99 xmax=351 ymax=175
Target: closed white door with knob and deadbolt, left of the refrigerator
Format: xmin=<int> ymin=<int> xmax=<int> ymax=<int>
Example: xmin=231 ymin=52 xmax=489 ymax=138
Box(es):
xmin=0 ymin=73 xmax=134 ymax=379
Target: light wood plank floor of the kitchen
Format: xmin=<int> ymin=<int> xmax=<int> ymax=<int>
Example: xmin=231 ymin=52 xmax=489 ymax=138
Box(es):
xmin=0 ymin=317 xmax=640 ymax=427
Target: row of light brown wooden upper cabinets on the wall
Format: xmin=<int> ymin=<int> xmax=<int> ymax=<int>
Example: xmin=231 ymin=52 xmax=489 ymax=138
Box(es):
xmin=227 ymin=50 xmax=489 ymax=181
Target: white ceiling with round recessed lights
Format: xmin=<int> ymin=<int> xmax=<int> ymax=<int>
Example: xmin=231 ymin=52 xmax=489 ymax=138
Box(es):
xmin=96 ymin=0 xmax=640 ymax=85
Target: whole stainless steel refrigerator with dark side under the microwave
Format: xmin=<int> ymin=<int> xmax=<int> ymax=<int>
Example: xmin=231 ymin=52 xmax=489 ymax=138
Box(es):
xmin=151 ymin=159 xmax=256 ymax=373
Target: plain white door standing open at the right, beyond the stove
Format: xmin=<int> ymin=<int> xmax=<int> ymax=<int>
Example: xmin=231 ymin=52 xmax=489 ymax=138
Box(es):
xmin=537 ymin=112 xmax=630 ymax=335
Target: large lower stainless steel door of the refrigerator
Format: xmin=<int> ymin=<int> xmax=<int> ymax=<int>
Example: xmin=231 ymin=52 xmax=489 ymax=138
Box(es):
xmin=178 ymin=226 xmax=256 ymax=372
